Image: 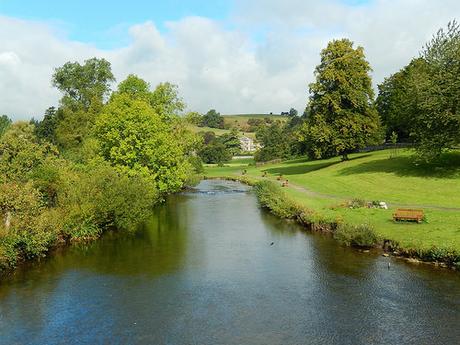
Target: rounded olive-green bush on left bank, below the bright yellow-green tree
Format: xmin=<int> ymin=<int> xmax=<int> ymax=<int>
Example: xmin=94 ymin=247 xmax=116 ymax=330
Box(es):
xmin=58 ymin=164 xmax=158 ymax=236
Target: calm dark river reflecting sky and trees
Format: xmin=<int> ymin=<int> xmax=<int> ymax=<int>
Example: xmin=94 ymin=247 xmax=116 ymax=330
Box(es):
xmin=0 ymin=181 xmax=460 ymax=345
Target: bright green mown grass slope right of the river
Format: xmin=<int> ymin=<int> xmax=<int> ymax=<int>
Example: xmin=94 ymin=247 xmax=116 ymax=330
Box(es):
xmin=206 ymin=151 xmax=460 ymax=251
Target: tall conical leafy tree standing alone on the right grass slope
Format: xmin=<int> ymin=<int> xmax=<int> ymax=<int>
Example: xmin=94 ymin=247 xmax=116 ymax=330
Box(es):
xmin=301 ymin=39 xmax=379 ymax=160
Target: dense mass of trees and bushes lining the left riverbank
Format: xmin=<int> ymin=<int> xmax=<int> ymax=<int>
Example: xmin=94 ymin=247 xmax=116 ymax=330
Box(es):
xmin=0 ymin=58 xmax=201 ymax=270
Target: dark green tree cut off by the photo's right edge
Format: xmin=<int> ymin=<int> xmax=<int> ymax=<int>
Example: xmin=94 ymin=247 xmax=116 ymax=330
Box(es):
xmin=412 ymin=21 xmax=460 ymax=161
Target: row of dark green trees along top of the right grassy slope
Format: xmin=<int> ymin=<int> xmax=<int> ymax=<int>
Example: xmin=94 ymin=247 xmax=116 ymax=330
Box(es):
xmin=256 ymin=21 xmax=460 ymax=161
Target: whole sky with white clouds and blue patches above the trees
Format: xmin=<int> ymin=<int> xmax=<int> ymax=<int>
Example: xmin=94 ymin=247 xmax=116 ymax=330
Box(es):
xmin=0 ymin=0 xmax=460 ymax=119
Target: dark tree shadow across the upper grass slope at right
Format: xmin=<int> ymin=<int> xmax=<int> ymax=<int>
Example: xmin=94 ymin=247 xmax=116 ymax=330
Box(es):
xmin=339 ymin=152 xmax=460 ymax=178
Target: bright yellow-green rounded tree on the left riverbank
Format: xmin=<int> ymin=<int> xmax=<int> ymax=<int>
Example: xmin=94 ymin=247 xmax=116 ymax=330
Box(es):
xmin=95 ymin=94 xmax=190 ymax=193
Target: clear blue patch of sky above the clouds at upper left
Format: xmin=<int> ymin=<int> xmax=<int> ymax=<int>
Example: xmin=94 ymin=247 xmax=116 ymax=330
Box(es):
xmin=0 ymin=0 xmax=232 ymax=48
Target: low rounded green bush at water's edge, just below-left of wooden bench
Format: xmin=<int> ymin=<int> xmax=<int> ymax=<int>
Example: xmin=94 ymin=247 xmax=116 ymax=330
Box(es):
xmin=334 ymin=224 xmax=380 ymax=248
